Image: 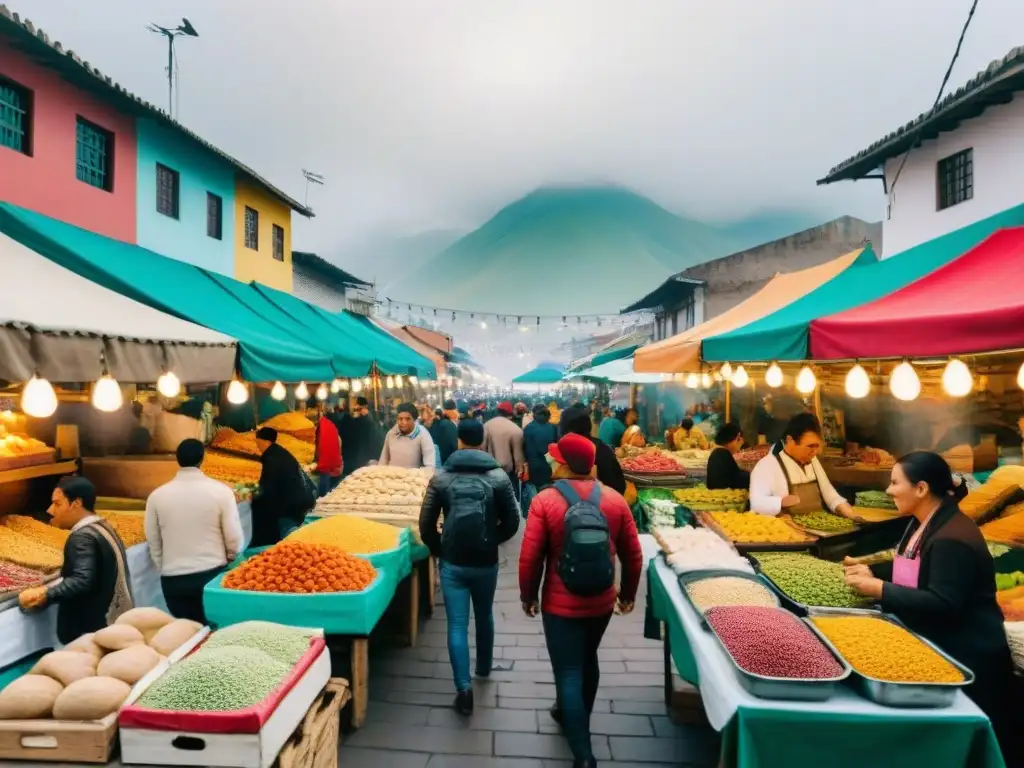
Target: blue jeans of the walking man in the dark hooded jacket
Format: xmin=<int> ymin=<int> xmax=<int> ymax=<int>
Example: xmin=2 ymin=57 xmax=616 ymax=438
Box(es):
xmin=441 ymin=560 xmax=498 ymax=691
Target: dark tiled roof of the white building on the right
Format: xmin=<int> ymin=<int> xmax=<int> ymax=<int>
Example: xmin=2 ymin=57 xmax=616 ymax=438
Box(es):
xmin=818 ymin=46 xmax=1024 ymax=184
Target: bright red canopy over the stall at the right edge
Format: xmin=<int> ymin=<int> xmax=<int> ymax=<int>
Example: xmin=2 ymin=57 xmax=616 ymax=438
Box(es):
xmin=810 ymin=227 xmax=1024 ymax=360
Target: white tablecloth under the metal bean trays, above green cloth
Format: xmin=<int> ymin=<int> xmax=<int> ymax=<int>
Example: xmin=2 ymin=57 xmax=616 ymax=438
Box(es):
xmin=653 ymin=557 xmax=986 ymax=731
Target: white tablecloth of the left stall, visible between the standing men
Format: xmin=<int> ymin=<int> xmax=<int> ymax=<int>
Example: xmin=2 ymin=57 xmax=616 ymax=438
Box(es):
xmin=0 ymin=502 xmax=253 ymax=669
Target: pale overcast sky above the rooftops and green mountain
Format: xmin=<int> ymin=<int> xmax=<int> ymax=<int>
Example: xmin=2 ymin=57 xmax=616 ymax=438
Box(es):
xmin=19 ymin=0 xmax=1024 ymax=259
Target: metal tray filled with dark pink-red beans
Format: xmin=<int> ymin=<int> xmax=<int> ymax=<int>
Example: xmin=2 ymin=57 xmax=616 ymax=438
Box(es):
xmin=706 ymin=605 xmax=850 ymax=701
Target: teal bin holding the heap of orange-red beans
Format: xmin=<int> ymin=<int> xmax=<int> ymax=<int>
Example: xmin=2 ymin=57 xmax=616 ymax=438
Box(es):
xmin=203 ymin=542 xmax=398 ymax=636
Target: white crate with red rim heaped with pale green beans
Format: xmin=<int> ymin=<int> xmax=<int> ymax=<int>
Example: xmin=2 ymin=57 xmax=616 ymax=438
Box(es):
xmin=120 ymin=623 xmax=331 ymax=768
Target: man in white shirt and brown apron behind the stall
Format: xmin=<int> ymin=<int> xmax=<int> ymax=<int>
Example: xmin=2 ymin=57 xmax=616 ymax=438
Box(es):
xmin=751 ymin=413 xmax=853 ymax=517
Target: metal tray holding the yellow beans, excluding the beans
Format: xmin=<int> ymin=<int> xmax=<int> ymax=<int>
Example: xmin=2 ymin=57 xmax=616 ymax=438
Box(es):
xmin=804 ymin=608 xmax=974 ymax=708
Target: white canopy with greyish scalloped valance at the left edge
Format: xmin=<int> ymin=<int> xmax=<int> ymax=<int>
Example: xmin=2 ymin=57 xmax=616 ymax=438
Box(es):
xmin=0 ymin=233 xmax=236 ymax=383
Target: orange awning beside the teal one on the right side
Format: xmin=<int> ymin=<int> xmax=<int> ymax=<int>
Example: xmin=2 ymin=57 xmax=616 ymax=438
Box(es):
xmin=633 ymin=248 xmax=863 ymax=374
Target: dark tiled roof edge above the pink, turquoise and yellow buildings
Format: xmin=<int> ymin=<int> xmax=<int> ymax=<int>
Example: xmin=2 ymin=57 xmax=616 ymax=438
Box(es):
xmin=0 ymin=3 xmax=313 ymax=217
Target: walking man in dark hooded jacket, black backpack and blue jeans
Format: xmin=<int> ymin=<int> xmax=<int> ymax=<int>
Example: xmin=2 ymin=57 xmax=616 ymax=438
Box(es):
xmin=420 ymin=419 xmax=519 ymax=715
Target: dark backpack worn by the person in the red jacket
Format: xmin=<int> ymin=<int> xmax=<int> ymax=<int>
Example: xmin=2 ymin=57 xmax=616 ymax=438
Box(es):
xmin=555 ymin=480 xmax=615 ymax=597
